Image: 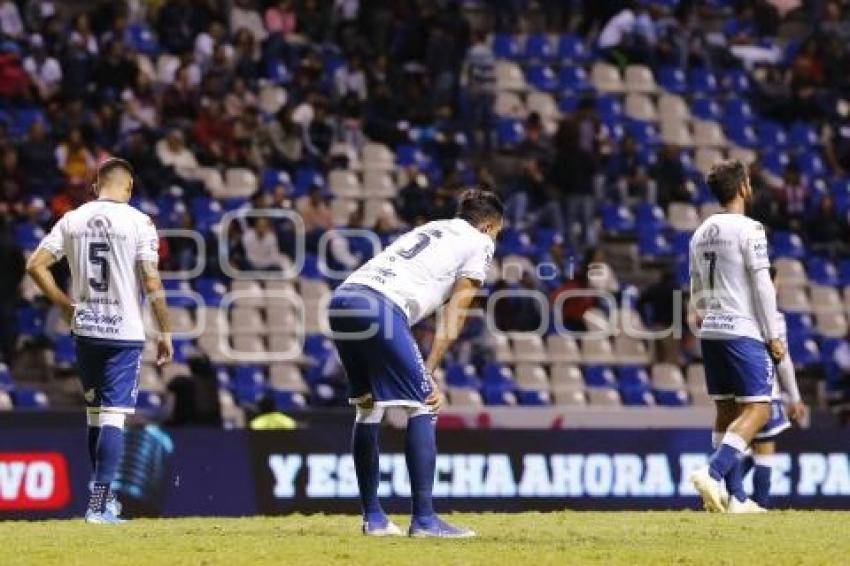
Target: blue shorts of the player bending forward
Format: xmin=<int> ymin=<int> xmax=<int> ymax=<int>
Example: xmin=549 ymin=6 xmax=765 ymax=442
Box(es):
xmin=328 ymin=284 xmax=431 ymax=407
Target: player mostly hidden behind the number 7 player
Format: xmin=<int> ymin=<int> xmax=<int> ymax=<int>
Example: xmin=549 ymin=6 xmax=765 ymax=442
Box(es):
xmin=740 ymin=268 xmax=806 ymax=508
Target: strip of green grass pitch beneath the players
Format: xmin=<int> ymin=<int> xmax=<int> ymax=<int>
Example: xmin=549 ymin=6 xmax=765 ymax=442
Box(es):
xmin=0 ymin=511 xmax=850 ymax=566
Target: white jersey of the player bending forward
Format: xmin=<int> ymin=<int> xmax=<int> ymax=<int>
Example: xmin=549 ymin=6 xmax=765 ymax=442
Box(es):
xmin=345 ymin=218 xmax=494 ymax=325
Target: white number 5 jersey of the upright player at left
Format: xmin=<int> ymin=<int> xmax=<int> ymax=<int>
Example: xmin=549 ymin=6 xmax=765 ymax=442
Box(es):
xmin=41 ymin=199 xmax=159 ymax=342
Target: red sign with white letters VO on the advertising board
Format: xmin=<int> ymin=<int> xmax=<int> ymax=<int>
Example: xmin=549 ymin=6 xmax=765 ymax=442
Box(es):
xmin=0 ymin=452 xmax=71 ymax=511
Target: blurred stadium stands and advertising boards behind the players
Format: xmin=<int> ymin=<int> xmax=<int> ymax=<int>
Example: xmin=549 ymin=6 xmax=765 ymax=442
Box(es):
xmin=0 ymin=0 xmax=850 ymax=518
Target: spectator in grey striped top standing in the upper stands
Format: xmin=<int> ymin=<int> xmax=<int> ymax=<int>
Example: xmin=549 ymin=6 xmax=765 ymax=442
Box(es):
xmin=463 ymin=32 xmax=496 ymax=152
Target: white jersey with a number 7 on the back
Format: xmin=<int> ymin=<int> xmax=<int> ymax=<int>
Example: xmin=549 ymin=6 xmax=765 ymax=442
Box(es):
xmin=690 ymin=213 xmax=770 ymax=342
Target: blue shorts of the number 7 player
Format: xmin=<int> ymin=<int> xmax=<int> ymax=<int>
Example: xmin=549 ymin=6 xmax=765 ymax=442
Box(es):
xmin=700 ymin=337 xmax=776 ymax=403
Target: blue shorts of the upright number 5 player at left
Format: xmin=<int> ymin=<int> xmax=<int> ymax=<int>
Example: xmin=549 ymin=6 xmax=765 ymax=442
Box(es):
xmin=74 ymin=336 xmax=144 ymax=413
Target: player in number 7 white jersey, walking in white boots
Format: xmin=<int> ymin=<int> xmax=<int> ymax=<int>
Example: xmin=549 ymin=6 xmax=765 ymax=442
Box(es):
xmin=690 ymin=160 xmax=785 ymax=513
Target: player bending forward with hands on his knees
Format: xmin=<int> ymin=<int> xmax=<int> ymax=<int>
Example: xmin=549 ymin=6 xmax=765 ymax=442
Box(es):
xmin=329 ymin=189 xmax=496 ymax=538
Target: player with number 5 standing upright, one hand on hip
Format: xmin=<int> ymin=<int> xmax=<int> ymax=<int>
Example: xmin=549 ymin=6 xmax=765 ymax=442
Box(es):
xmin=27 ymin=158 xmax=174 ymax=524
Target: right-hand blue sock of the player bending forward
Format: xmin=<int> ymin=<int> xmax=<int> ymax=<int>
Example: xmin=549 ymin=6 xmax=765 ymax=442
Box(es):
xmin=404 ymin=414 xmax=437 ymax=519
